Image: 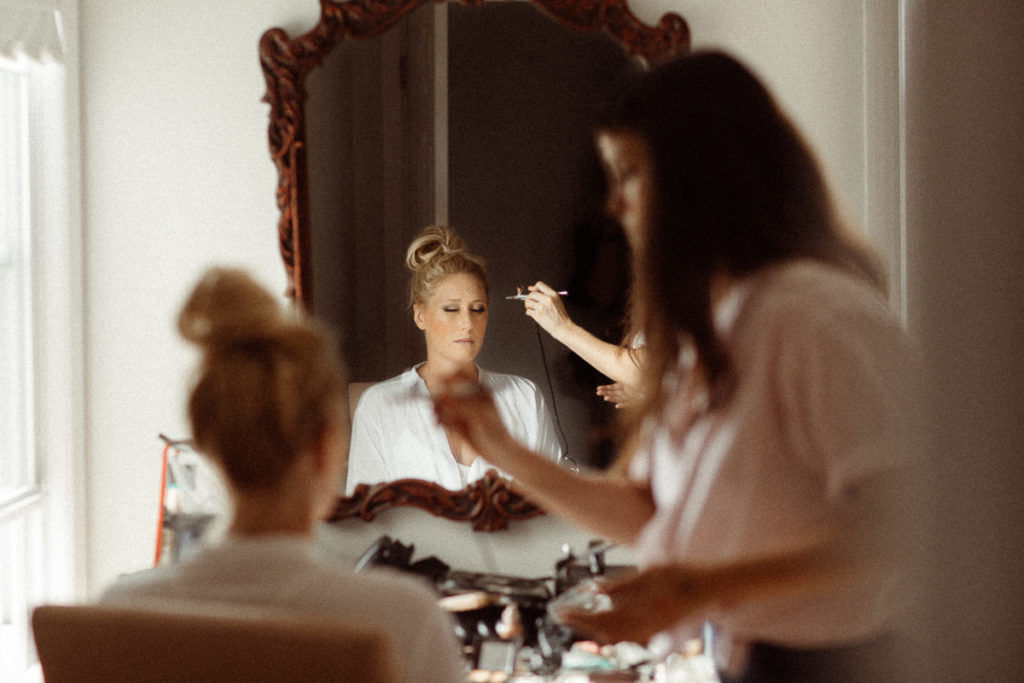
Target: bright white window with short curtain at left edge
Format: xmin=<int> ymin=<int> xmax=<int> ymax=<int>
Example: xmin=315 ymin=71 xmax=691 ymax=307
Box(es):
xmin=0 ymin=0 xmax=82 ymax=681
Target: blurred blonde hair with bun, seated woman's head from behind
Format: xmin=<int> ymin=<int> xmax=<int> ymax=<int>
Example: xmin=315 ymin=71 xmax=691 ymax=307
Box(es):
xmin=177 ymin=268 xmax=344 ymax=489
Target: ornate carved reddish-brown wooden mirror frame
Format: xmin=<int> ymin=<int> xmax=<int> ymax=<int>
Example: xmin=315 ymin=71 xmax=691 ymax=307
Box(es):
xmin=259 ymin=0 xmax=690 ymax=530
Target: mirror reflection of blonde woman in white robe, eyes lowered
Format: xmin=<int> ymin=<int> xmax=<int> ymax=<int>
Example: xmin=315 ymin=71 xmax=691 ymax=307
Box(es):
xmin=346 ymin=225 xmax=561 ymax=494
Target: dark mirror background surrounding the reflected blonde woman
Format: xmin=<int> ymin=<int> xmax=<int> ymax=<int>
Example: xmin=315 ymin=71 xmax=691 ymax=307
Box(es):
xmin=305 ymin=3 xmax=630 ymax=492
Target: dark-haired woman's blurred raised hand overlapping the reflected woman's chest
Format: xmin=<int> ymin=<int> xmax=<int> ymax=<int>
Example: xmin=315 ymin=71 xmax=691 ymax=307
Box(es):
xmin=434 ymin=374 xmax=515 ymax=467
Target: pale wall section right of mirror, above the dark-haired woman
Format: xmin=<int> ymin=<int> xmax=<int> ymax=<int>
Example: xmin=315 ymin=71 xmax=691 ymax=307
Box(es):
xmin=633 ymin=0 xmax=904 ymax=305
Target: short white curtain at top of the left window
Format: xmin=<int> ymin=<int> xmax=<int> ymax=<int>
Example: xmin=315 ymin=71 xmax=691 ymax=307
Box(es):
xmin=0 ymin=0 xmax=65 ymax=63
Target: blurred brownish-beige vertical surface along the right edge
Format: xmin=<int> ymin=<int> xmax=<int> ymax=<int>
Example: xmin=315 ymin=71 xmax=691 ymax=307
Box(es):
xmin=906 ymin=0 xmax=1024 ymax=681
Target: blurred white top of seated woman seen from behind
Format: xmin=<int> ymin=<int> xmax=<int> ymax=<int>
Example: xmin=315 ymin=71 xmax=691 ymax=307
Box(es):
xmin=99 ymin=535 xmax=466 ymax=683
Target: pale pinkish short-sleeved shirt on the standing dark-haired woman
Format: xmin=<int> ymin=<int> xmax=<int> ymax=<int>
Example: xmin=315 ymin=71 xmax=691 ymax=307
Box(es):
xmin=630 ymin=262 xmax=912 ymax=647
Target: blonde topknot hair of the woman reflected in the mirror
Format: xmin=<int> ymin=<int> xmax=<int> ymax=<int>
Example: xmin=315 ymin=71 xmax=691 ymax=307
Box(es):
xmin=406 ymin=225 xmax=490 ymax=306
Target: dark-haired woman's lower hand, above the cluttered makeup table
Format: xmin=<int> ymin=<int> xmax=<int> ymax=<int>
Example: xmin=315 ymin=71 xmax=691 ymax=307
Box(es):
xmin=558 ymin=565 xmax=707 ymax=643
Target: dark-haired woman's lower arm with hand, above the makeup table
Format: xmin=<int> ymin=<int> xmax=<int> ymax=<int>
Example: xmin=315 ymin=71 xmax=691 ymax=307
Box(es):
xmin=559 ymin=468 xmax=913 ymax=642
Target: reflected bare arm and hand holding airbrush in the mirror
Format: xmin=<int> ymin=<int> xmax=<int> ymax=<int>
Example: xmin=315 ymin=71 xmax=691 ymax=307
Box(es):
xmin=523 ymin=282 xmax=643 ymax=387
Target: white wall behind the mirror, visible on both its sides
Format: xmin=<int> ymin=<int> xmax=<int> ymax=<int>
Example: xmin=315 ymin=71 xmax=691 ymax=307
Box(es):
xmin=81 ymin=0 xmax=895 ymax=593
